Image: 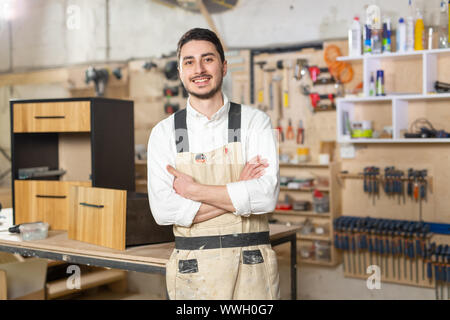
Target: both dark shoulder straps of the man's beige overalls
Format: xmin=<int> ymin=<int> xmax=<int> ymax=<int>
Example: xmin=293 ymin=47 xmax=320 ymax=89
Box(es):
xmin=174 ymin=102 xmax=242 ymax=153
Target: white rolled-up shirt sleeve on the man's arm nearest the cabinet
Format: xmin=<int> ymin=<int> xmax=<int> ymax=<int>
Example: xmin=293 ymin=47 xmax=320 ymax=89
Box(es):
xmin=147 ymin=122 xmax=201 ymax=227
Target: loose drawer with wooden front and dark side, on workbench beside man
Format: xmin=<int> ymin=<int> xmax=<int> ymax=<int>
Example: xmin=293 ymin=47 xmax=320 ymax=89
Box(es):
xmin=68 ymin=187 xmax=174 ymax=250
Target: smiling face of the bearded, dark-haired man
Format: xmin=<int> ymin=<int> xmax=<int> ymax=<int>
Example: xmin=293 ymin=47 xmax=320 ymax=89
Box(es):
xmin=179 ymin=40 xmax=227 ymax=99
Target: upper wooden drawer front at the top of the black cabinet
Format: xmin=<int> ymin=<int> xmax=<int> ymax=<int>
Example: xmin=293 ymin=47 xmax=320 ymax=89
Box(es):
xmin=13 ymin=101 xmax=91 ymax=132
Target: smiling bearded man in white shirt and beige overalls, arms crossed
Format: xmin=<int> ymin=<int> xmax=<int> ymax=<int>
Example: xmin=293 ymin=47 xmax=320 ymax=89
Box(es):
xmin=148 ymin=28 xmax=280 ymax=299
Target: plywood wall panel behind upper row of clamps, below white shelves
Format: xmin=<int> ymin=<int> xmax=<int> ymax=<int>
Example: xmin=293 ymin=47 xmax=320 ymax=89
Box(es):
xmin=342 ymin=144 xmax=450 ymax=223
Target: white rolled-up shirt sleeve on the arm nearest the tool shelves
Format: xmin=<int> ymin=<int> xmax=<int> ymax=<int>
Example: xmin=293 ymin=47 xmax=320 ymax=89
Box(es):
xmin=227 ymin=110 xmax=280 ymax=216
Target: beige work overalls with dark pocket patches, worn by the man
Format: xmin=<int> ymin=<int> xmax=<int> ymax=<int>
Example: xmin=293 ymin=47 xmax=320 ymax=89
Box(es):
xmin=166 ymin=104 xmax=280 ymax=300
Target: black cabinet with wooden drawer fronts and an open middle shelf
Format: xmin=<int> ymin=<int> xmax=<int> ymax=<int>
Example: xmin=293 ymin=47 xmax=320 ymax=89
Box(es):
xmin=10 ymin=98 xmax=135 ymax=230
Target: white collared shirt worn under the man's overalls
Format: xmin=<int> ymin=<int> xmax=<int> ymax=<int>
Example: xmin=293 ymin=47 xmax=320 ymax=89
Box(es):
xmin=147 ymin=94 xmax=280 ymax=227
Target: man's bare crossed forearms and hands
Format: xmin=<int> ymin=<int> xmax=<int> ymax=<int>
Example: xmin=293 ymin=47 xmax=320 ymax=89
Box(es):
xmin=167 ymin=156 xmax=269 ymax=223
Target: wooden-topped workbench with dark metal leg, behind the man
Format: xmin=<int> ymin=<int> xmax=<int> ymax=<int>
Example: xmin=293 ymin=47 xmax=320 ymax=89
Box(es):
xmin=0 ymin=224 xmax=300 ymax=299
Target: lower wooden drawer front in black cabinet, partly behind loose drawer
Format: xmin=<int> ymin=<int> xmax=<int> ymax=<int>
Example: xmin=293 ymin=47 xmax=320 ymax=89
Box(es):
xmin=14 ymin=180 xmax=91 ymax=230
